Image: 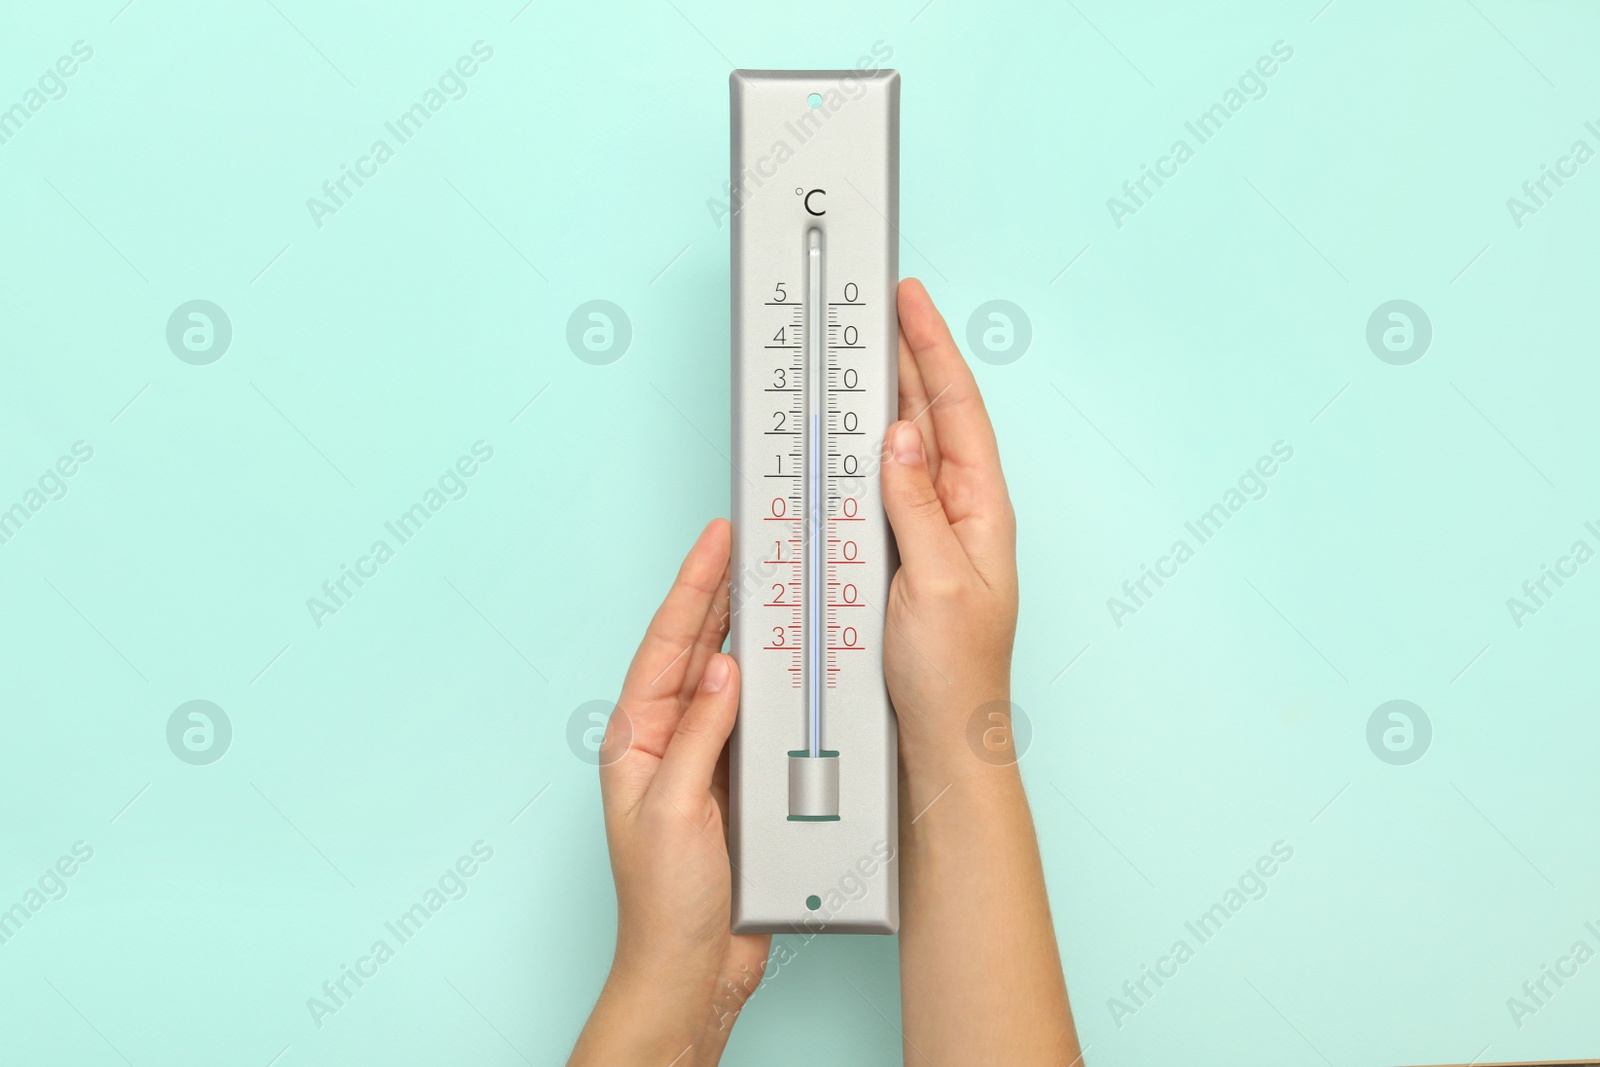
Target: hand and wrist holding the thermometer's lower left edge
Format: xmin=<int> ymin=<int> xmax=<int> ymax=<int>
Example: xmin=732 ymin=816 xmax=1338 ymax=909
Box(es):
xmin=570 ymin=518 xmax=771 ymax=1067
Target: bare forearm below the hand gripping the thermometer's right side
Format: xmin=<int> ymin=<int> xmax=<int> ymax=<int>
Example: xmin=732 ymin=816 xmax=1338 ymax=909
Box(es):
xmin=899 ymin=737 xmax=1078 ymax=1067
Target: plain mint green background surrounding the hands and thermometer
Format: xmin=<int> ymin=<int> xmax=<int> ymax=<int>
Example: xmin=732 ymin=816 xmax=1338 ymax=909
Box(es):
xmin=0 ymin=0 xmax=1600 ymax=1067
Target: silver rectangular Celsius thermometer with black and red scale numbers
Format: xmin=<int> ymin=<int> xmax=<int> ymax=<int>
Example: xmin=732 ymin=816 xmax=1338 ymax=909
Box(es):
xmin=730 ymin=70 xmax=899 ymax=933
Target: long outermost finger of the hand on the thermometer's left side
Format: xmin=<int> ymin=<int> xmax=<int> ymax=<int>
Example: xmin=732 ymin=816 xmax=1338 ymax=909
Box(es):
xmin=600 ymin=518 xmax=730 ymax=808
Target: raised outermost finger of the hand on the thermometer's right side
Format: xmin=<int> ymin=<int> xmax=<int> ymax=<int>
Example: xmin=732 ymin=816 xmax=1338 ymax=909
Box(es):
xmin=899 ymin=278 xmax=1005 ymax=508
